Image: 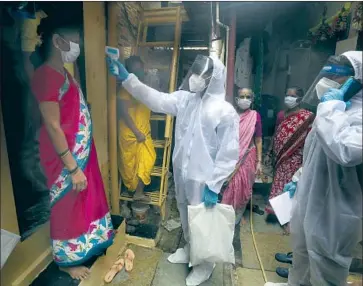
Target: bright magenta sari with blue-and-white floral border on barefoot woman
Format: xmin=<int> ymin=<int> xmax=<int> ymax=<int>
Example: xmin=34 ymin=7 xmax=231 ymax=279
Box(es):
xmin=32 ymin=65 xmax=114 ymax=267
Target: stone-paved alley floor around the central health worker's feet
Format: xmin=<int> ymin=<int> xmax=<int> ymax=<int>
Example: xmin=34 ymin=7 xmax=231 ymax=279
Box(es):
xmin=29 ymin=185 xmax=361 ymax=286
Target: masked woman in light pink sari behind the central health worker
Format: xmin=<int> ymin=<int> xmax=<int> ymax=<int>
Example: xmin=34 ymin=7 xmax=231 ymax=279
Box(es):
xmin=222 ymin=88 xmax=262 ymax=224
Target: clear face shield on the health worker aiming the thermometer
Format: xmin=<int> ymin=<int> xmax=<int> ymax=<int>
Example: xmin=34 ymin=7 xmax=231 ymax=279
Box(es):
xmin=179 ymin=55 xmax=213 ymax=93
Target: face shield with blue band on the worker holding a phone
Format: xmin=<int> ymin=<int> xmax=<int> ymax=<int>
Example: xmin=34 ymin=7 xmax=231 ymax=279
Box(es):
xmin=301 ymin=56 xmax=354 ymax=110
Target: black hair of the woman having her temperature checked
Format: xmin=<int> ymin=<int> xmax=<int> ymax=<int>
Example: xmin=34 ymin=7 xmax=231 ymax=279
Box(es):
xmin=35 ymin=13 xmax=82 ymax=64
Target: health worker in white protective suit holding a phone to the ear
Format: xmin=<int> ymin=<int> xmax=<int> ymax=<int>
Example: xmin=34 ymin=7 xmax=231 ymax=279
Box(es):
xmin=266 ymin=51 xmax=363 ymax=286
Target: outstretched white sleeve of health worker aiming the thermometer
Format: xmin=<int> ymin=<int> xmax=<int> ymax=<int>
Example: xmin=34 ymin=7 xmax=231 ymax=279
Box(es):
xmin=122 ymin=74 xmax=187 ymax=116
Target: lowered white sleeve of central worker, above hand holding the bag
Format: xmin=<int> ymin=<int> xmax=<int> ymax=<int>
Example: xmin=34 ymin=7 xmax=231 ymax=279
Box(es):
xmin=206 ymin=110 xmax=239 ymax=194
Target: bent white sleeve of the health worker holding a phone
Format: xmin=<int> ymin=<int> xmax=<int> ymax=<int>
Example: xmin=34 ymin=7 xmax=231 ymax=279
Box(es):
xmin=314 ymin=100 xmax=362 ymax=167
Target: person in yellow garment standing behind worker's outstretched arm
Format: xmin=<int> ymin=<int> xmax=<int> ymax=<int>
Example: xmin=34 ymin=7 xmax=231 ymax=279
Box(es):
xmin=118 ymin=56 xmax=156 ymax=201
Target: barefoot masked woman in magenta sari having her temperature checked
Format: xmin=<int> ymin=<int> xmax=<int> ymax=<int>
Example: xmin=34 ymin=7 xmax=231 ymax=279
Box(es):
xmin=31 ymin=14 xmax=114 ymax=280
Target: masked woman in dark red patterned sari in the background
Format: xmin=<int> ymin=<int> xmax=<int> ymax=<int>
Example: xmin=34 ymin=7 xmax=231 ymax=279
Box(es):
xmin=265 ymin=87 xmax=314 ymax=232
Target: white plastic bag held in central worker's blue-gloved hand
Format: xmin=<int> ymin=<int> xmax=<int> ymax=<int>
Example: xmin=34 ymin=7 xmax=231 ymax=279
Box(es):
xmin=188 ymin=203 xmax=236 ymax=266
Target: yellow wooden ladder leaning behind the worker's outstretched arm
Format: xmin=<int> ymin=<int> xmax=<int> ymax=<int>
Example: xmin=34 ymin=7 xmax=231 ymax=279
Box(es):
xmin=119 ymin=6 xmax=189 ymax=220
